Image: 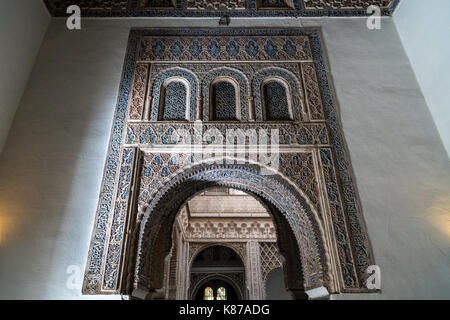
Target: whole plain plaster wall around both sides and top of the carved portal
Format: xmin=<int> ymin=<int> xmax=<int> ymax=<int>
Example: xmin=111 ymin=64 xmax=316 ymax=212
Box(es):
xmin=0 ymin=18 xmax=450 ymax=299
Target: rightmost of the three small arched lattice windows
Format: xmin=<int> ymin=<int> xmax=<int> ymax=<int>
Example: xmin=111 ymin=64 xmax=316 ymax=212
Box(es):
xmin=263 ymin=81 xmax=291 ymax=120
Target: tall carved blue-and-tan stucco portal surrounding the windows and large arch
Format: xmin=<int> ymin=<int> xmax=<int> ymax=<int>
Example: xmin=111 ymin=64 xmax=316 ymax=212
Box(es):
xmin=83 ymin=28 xmax=374 ymax=294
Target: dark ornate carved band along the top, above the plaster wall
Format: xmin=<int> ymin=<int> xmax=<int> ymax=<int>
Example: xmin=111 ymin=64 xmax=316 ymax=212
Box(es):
xmin=43 ymin=0 xmax=400 ymax=17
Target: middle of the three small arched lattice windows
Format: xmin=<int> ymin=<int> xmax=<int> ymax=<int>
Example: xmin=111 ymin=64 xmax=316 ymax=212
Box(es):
xmin=212 ymin=81 xmax=237 ymax=120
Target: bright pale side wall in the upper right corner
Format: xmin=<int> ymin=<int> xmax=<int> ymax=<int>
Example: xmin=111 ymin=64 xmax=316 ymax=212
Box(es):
xmin=394 ymin=0 xmax=450 ymax=158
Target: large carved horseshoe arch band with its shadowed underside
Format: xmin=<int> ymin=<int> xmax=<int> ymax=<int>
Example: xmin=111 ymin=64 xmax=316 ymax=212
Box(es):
xmin=130 ymin=164 xmax=332 ymax=298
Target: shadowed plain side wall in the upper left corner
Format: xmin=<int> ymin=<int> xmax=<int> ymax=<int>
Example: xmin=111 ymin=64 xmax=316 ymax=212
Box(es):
xmin=0 ymin=0 xmax=50 ymax=155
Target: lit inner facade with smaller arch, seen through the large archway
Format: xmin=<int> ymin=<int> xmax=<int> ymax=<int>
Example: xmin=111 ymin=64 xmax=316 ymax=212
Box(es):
xmin=165 ymin=187 xmax=287 ymax=300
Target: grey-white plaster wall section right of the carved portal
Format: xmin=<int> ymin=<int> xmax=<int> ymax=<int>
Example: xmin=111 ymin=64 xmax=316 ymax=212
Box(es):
xmin=314 ymin=19 xmax=450 ymax=299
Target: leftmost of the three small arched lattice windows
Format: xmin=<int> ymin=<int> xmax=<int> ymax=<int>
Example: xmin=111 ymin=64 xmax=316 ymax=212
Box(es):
xmin=160 ymin=81 xmax=187 ymax=120
